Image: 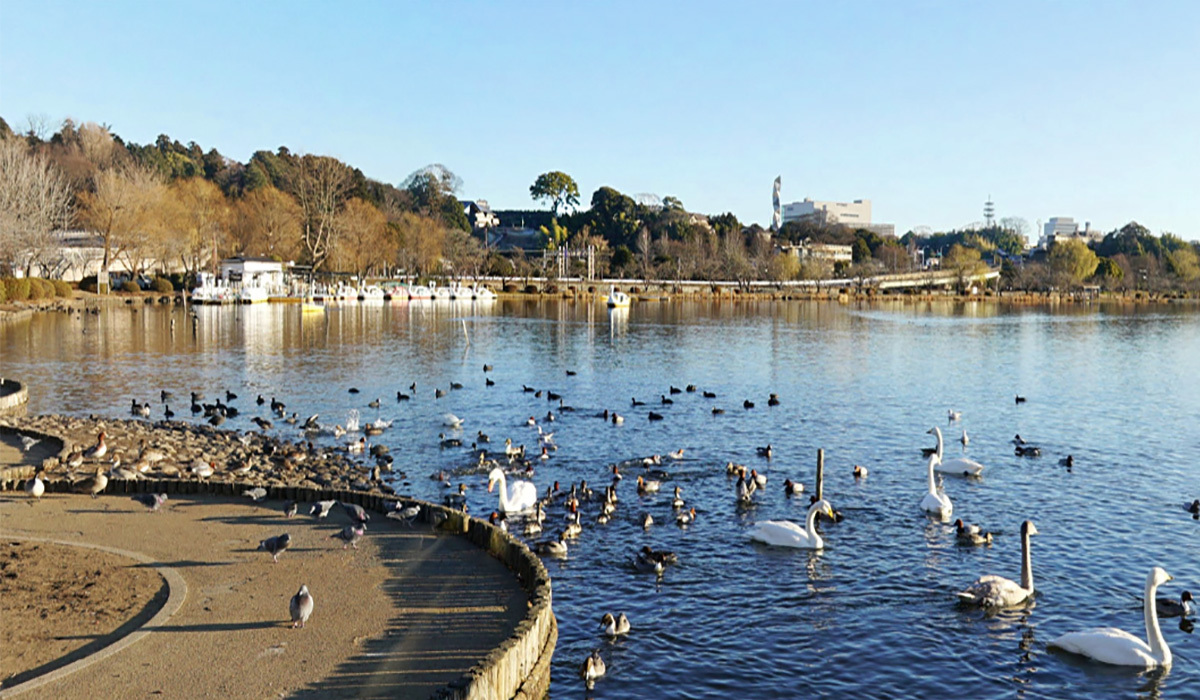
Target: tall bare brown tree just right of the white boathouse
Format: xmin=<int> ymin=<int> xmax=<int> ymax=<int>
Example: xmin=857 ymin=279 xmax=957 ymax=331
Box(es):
xmin=289 ymin=155 xmax=350 ymax=270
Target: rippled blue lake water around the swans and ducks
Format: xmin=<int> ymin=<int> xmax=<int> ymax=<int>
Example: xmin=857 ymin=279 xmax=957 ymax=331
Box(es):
xmin=0 ymin=301 xmax=1200 ymax=699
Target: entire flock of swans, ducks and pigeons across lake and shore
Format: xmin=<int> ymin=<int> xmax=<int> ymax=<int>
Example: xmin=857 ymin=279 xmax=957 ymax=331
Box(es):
xmin=26 ymin=365 xmax=1200 ymax=686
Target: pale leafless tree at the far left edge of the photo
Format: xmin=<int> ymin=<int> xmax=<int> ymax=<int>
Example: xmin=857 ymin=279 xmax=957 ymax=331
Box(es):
xmin=0 ymin=138 xmax=71 ymax=275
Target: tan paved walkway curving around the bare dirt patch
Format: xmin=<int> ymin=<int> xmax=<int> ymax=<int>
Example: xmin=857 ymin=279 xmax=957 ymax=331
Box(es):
xmin=0 ymin=493 xmax=527 ymax=699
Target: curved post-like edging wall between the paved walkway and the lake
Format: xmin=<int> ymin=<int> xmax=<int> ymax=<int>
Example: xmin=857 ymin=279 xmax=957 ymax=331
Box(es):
xmin=0 ymin=475 xmax=558 ymax=700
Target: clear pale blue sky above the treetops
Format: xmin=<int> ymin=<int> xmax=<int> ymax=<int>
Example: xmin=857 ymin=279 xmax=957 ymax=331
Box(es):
xmin=0 ymin=0 xmax=1200 ymax=240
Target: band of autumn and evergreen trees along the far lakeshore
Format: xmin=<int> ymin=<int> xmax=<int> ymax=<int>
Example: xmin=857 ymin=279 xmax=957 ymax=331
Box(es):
xmin=0 ymin=119 xmax=1200 ymax=291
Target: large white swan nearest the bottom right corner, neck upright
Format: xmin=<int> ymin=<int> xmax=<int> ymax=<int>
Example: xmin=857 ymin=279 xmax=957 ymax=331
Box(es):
xmin=1050 ymin=567 xmax=1172 ymax=669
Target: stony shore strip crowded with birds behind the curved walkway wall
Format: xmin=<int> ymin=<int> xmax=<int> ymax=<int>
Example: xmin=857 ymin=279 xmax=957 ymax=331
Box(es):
xmin=0 ymin=414 xmax=394 ymax=495
